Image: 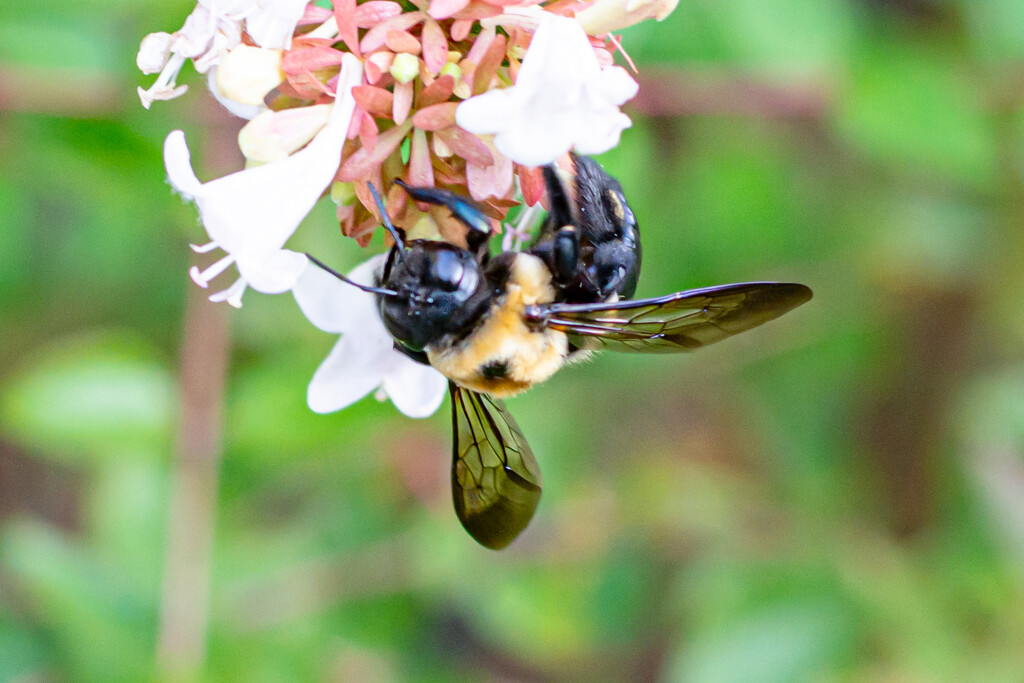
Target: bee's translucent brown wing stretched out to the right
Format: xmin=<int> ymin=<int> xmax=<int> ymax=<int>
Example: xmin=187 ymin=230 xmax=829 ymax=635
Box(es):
xmin=540 ymin=283 xmax=811 ymax=353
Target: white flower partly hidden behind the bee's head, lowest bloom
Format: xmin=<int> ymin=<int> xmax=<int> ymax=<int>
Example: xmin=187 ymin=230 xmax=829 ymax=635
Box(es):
xmin=292 ymin=254 xmax=447 ymax=418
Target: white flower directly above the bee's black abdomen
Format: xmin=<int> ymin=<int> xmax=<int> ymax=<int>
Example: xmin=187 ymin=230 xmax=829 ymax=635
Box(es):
xmin=456 ymin=15 xmax=638 ymax=166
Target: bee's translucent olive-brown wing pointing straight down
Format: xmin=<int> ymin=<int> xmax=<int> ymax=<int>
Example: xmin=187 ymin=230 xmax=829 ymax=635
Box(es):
xmin=449 ymin=382 xmax=541 ymax=550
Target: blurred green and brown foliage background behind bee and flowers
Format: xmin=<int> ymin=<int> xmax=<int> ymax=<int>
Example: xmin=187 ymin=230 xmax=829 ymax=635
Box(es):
xmin=0 ymin=0 xmax=1024 ymax=682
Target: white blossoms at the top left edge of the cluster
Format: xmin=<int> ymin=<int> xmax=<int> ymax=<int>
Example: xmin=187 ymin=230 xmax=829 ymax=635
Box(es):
xmin=136 ymin=0 xmax=308 ymax=109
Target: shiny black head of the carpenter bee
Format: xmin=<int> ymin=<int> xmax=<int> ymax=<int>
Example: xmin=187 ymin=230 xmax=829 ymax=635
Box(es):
xmin=379 ymin=240 xmax=488 ymax=351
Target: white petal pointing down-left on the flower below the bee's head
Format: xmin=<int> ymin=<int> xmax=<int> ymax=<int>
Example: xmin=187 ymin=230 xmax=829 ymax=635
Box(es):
xmin=306 ymin=335 xmax=394 ymax=413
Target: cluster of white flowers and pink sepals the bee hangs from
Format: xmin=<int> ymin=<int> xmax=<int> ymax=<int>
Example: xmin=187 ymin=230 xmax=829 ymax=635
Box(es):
xmin=137 ymin=0 xmax=678 ymax=415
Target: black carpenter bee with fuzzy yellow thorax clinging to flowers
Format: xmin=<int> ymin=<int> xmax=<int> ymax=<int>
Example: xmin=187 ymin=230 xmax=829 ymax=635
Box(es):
xmin=310 ymin=155 xmax=811 ymax=550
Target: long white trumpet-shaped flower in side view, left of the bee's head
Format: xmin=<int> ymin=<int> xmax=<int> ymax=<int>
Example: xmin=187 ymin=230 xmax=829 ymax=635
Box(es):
xmin=164 ymin=54 xmax=362 ymax=306
